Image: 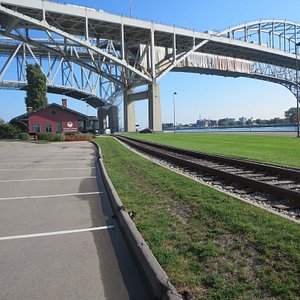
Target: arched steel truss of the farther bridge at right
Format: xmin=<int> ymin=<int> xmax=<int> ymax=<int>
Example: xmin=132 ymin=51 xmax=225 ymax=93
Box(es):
xmin=173 ymin=20 xmax=300 ymax=96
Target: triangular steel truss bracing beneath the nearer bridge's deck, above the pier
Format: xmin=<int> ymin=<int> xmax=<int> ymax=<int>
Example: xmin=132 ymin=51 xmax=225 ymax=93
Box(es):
xmin=0 ymin=0 xmax=207 ymax=101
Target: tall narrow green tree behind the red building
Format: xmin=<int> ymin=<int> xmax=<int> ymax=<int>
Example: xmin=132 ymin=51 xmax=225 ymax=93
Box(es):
xmin=25 ymin=64 xmax=48 ymax=110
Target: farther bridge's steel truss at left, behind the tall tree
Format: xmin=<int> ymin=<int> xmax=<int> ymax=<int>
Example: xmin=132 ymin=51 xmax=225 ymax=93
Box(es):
xmin=0 ymin=36 xmax=123 ymax=107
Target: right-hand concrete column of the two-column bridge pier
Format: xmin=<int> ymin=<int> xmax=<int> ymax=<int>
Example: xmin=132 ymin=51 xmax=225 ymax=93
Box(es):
xmin=148 ymin=83 xmax=162 ymax=131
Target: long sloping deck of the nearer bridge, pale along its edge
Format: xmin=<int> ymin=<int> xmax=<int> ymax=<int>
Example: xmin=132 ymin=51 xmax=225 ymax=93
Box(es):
xmin=0 ymin=0 xmax=295 ymax=68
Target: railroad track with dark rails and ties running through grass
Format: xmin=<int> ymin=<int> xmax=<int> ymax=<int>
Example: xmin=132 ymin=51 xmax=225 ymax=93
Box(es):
xmin=116 ymin=136 xmax=300 ymax=210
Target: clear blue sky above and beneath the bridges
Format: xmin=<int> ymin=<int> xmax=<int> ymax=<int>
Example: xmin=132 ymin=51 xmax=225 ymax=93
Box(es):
xmin=0 ymin=0 xmax=300 ymax=128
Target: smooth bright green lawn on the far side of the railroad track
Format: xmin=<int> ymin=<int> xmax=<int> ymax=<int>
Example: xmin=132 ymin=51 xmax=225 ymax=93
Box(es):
xmin=125 ymin=133 xmax=300 ymax=168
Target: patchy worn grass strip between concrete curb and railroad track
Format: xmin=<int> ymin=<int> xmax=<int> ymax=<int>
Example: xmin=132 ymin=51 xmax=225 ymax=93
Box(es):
xmin=95 ymin=135 xmax=300 ymax=300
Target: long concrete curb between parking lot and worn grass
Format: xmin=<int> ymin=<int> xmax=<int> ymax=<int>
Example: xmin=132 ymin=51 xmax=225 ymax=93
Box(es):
xmin=92 ymin=142 xmax=182 ymax=300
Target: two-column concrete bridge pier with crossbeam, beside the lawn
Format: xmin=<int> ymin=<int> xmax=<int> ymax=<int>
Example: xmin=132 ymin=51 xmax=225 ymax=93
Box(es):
xmin=124 ymin=83 xmax=162 ymax=132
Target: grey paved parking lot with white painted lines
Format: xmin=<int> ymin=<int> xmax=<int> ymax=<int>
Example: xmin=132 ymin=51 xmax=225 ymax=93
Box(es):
xmin=0 ymin=142 xmax=148 ymax=300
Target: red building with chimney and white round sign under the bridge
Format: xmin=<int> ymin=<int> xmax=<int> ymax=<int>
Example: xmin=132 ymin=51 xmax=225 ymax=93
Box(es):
xmin=11 ymin=99 xmax=99 ymax=134
